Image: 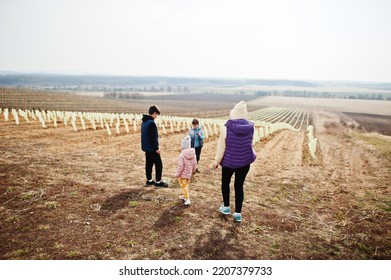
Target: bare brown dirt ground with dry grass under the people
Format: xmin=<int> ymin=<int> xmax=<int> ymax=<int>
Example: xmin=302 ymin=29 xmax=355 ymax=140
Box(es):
xmin=0 ymin=103 xmax=391 ymax=259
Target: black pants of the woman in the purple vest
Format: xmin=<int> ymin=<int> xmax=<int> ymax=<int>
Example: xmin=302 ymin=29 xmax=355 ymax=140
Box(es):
xmin=221 ymin=165 xmax=250 ymax=213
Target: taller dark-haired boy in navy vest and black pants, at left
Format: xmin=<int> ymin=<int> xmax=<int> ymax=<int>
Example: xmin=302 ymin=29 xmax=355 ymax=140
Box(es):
xmin=141 ymin=105 xmax=168 ymax=188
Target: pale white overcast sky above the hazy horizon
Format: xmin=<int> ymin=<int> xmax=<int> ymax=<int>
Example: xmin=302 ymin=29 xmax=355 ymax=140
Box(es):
xmin=0 ymin=0 xmax=391 ymax=82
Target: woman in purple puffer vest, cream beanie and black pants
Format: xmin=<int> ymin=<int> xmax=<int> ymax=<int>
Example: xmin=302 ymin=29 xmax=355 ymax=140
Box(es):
xmin=213 ymin=101 xmax=257 ymax=222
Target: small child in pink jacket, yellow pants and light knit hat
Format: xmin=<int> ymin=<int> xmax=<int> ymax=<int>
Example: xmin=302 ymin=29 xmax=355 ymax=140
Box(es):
xmin=175 ymin=135 xmax=197 ymax=205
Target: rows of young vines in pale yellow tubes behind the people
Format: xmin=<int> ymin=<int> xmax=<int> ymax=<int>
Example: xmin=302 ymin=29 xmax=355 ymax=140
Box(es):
xmin=0 ymin=107 xmax=316 ymax=152
